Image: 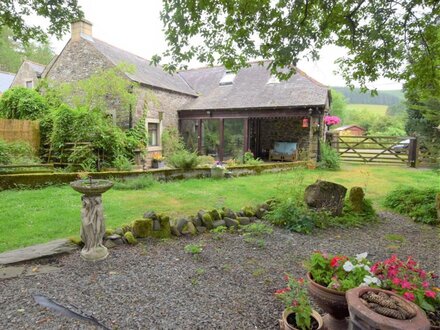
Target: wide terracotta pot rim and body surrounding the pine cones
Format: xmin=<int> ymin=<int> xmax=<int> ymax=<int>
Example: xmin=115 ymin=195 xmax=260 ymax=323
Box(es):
xmin=346 ymin=287 xmax=430 ymax=330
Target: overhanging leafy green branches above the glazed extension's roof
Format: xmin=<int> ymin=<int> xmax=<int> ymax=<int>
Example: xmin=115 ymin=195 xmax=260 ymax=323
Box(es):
xmin=154 ymin=0 xmax=440 ymax=90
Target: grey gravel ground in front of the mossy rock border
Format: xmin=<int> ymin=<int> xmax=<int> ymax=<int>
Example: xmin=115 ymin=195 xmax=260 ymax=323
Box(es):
xmin=0 ymin=213 xmax=440 ymax=329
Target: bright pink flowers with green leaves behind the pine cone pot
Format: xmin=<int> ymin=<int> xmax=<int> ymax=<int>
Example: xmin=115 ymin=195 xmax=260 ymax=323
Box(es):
xmin=371 ymin=255 xmax=440 ymax=329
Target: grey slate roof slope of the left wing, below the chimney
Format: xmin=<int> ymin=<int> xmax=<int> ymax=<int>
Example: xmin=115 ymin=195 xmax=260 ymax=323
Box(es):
xmin=84 ymin=37 xmax=196 ymax=96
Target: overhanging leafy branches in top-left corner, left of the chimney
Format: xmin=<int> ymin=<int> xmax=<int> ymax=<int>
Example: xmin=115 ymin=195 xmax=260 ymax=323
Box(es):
xmin=0 ymin=0 xmax=83 ymax=43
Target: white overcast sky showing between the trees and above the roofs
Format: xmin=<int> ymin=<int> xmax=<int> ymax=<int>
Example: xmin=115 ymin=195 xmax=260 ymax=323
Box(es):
xmin=46 ymin=0 xmax=401 ymax=89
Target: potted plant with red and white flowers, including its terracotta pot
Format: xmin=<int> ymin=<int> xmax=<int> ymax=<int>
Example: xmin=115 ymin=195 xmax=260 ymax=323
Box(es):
xmin=306 ymin=252 xmax=380 ymax=329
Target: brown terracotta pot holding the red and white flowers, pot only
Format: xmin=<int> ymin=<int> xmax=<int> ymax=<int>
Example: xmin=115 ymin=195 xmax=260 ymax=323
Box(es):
xmin=307 ymin=273 xmax=349 ymax=330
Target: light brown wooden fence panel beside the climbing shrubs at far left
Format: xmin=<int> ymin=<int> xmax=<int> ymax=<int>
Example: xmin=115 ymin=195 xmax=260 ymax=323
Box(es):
xmin=0 ymin=119 xmax=40 ymax=154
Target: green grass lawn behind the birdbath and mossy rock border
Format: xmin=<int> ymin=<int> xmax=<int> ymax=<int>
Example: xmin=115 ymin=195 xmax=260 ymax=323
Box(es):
xmin=0 ymin=165 xmax=440 ymax=252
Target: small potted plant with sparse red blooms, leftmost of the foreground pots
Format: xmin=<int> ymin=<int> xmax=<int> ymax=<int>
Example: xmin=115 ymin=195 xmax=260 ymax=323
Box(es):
xmin=275 ymin=275 xmax=323 ymax=330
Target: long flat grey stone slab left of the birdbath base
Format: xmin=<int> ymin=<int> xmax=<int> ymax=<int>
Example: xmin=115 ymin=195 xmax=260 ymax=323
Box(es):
xmin=0 ymin=239 xmax=78 ymax=265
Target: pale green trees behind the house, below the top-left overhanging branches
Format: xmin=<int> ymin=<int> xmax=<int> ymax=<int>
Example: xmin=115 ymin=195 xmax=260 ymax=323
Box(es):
xmin=0 ymin=28 xmax=54 ymax=72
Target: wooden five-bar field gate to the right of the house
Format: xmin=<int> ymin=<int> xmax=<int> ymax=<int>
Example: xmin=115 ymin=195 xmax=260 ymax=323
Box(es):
xmin=328 ymin=134 xmax=418 ymax=167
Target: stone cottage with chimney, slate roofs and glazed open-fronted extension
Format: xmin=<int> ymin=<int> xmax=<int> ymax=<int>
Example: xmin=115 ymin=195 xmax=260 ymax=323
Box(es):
xmin=43 ymin=20 xmax=330 ymax=160
